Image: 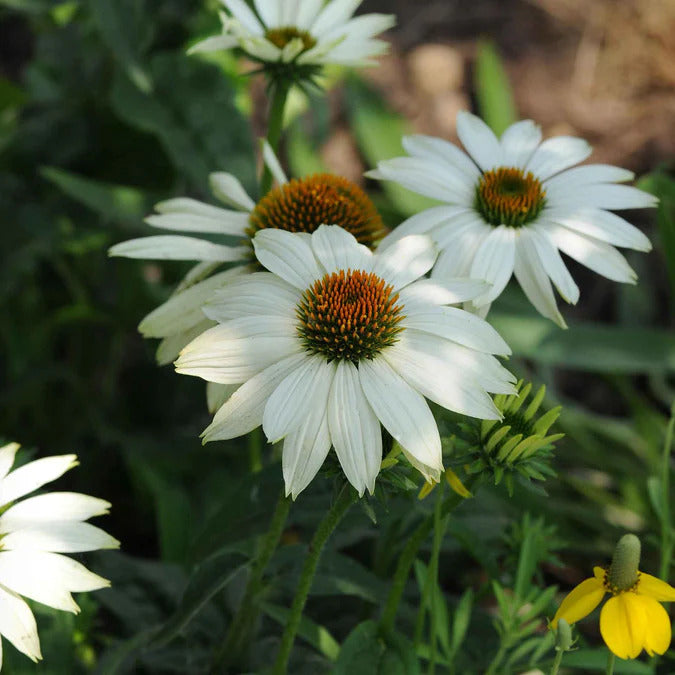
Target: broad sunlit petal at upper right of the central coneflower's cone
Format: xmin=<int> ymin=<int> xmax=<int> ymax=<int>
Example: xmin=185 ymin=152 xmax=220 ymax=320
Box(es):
xmin=373 ymin=234 xmax=438 ymax=290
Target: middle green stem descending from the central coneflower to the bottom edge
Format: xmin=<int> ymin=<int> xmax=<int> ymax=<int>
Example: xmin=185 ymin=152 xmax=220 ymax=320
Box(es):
xmin=272 ymin=485 xmax=356 ymax=675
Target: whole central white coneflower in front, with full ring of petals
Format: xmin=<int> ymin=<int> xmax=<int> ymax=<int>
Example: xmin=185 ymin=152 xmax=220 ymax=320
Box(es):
xmin=176 ymin=225 xmax=515 ymax=498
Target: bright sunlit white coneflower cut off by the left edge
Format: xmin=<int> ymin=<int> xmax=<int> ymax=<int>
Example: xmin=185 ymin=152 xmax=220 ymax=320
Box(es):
xmin=0 ymin=443 xmax=119 ymax=667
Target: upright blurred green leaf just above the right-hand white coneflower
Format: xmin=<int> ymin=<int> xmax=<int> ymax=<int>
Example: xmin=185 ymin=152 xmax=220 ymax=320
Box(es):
xmin=475 ymin=41 xmax=518 ymax=136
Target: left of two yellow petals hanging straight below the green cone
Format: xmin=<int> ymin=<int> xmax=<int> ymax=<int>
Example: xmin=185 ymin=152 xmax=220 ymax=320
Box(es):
xmin=600 ymin=591 xmax=647 ymax=659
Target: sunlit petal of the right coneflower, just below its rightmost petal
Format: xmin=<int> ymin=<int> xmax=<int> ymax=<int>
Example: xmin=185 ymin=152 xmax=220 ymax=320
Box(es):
xmin=543 ymin=208 xmax=652 ymax=251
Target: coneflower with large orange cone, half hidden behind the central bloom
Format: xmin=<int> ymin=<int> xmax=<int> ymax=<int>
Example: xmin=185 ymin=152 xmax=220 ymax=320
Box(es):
xmin=110 ymin=143 xmax=386 ymax=412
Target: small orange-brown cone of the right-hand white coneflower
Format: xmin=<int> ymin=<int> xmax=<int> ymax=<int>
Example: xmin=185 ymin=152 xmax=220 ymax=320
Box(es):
xmin=476 ymin=167 xmax=546 ymax=227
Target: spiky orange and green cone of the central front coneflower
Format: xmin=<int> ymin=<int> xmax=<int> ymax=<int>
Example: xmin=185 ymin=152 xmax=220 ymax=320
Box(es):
xmin=297 ymin=269 xmax=404 ymax=363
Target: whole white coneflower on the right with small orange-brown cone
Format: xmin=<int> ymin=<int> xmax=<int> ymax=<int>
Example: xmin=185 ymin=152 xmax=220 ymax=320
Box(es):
xmin=368 ymin=112 xmax=657 ymax=327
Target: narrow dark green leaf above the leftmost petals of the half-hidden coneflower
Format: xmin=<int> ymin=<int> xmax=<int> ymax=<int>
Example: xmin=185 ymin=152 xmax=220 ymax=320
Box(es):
xmin=40 ymin=167 xmax=152 ymax=224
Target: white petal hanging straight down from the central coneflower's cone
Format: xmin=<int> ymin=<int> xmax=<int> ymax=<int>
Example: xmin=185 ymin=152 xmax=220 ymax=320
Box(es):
xmin=328 ymin=361 xmax=382 ymax=496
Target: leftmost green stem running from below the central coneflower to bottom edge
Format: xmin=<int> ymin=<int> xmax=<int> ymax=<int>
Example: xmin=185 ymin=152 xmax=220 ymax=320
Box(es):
xmin=212 ymin=490 xmax=291 ymax=673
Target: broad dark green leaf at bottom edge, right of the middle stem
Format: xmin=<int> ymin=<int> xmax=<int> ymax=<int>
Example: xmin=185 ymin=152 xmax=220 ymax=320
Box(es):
xmin=333 ymin=621 xmax=420 ymax=675
